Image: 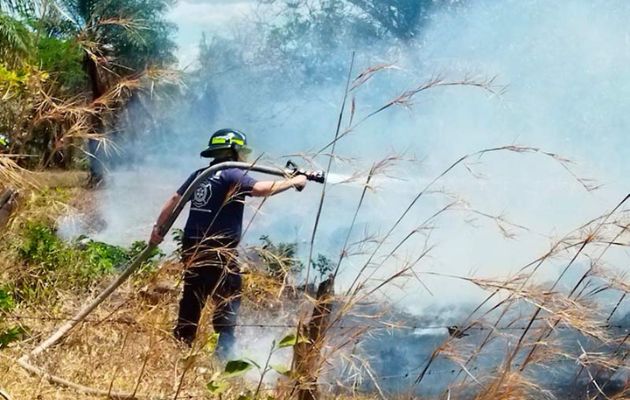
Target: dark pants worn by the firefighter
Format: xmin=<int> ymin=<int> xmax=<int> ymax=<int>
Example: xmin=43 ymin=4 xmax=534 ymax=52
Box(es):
xmin=174 ymin=240 xmax=242 ymax=356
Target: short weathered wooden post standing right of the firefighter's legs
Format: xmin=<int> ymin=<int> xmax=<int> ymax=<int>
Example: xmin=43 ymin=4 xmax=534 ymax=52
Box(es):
xmin=293 ymin=276 xmax=334 ymax=400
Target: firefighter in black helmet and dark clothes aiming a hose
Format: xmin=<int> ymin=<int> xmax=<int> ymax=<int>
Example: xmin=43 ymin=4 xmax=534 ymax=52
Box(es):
xmin=150 ymin=129 xmax=307 ymax=358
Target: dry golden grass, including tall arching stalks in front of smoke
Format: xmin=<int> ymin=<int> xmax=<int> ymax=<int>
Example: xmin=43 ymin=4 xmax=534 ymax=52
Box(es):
xmin=0 ymin=66 xmax=630 ymax=400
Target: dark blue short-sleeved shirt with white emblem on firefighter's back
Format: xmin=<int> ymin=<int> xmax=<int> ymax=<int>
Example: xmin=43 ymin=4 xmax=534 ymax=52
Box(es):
xmin=177 ymin=168 xmax=256 ymax=247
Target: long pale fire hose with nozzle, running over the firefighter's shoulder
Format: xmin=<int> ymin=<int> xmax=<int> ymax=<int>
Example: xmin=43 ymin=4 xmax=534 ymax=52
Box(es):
xmin=17 ymin=161 xmax=325 ymax=399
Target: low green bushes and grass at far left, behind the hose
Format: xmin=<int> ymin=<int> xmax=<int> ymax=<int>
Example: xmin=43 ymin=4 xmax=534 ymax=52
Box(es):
xmin=0 ymin=184 xmax=163 ymax=304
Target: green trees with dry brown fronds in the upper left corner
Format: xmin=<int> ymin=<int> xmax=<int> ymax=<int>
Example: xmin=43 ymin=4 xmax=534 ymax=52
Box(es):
xmin=0 ymin=0 xmax=176 ymax=175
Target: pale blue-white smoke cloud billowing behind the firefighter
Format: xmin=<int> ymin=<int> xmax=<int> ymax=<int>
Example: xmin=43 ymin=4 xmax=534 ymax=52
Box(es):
xmin=56 ymin=0 xmax=630 ymax=394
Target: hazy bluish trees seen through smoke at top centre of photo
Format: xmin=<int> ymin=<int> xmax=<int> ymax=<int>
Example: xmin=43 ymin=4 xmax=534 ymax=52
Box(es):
xmin=199 ymin=0 xmax=458 ymax=86
